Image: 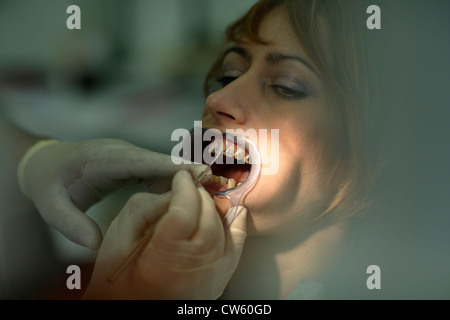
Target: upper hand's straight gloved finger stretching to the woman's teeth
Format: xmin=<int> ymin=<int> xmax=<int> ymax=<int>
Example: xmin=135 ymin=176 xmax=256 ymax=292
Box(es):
xmin=84 ymin=147 xmax=207 ymax=189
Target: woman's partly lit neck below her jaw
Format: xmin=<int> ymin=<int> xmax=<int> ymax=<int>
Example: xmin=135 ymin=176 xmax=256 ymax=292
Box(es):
xmin=222 ymin=218 xmax=345 ymax=299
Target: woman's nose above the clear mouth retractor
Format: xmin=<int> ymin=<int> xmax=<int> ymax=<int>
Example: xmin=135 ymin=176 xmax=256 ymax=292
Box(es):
xmin=206 ymin=78 xmax=252 ymax=126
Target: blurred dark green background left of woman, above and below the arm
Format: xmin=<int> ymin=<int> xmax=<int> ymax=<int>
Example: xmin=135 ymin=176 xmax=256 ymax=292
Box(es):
xmin=0 ymin=0 xmax=256 ymax=298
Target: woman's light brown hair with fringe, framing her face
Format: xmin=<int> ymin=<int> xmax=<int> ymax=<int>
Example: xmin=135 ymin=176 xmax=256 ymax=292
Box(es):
xmin=204 ymin=0 xmax=374 ymax=217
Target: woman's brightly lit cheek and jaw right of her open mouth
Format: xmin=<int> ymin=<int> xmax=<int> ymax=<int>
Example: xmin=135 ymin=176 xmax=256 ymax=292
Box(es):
xmin=246 ymin=110 xmax=340 ymax=232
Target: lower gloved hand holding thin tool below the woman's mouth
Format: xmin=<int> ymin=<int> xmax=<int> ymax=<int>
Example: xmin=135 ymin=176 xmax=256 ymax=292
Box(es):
xmin=84 ymin=171 xmax=247 ymax=299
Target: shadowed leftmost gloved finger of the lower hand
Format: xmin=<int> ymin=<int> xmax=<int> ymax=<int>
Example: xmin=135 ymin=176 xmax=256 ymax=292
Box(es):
xmin=104 ymin=192 xmax=171 ymax=251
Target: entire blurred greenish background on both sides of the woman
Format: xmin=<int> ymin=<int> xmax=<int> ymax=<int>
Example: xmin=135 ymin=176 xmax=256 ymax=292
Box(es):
xmin=0 ymin=0 xmax=450 ymax=299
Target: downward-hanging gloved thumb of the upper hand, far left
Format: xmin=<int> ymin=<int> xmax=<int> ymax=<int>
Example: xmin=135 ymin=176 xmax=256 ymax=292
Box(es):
xmin=35 ymin=189 xmax=103 ymax=250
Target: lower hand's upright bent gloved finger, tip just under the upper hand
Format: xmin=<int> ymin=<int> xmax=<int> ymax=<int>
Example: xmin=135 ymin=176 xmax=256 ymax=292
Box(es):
xmin=152 ymin=171 xmax=201 ymax=242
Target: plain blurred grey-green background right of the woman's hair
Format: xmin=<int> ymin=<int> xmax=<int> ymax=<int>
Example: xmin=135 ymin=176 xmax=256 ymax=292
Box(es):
xmin=330 ymin=0 xmax=450 ymax=300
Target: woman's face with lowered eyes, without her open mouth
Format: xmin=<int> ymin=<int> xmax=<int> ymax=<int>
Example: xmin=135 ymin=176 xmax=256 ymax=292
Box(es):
xmin=203 ymin=9 xmax=342 ymax=234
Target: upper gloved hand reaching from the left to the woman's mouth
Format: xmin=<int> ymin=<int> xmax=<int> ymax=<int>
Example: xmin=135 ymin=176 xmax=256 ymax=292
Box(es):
xmin=19 ymin=139 xmax=206 ymax=249
